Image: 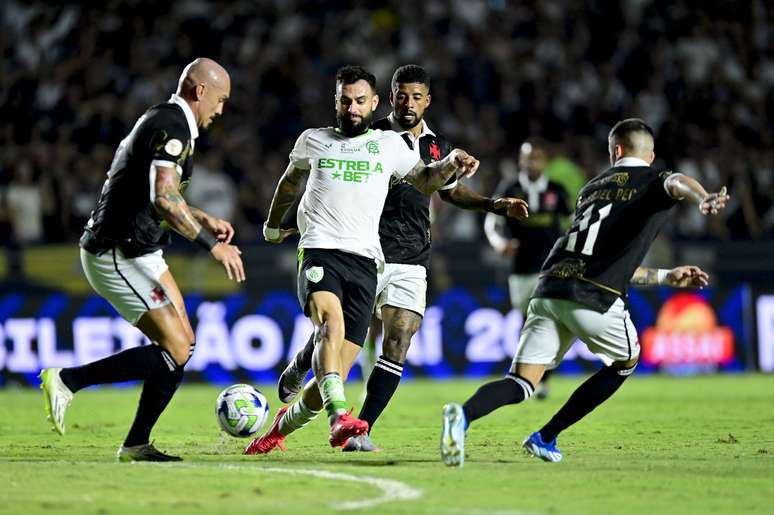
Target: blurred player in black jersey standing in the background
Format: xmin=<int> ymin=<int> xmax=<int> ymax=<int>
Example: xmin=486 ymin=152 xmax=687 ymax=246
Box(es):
xmin=484 ymin=138 xmax=571 ymax=399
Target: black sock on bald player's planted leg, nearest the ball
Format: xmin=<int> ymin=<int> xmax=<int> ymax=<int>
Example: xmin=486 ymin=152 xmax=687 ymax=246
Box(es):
xmin=124 ymin=365 xmax=183 ymax=447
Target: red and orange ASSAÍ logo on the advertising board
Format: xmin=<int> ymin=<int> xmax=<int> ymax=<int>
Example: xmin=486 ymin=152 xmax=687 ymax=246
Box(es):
xmin=642 ymin=293 xmax=734 ymax=366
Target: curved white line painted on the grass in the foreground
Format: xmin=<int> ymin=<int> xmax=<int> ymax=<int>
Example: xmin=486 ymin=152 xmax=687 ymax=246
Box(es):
xmin=194 ymin=463 xmax=422 ymax=510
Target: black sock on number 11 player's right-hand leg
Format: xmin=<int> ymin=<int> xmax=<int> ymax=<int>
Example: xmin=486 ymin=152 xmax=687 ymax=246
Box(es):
xmin=540 ymin=367 xmax=634 ymax=442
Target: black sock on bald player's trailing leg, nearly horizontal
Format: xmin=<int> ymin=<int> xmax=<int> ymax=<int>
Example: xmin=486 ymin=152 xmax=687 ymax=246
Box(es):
xmin=59 ymin=345 xmax=177 ymax=392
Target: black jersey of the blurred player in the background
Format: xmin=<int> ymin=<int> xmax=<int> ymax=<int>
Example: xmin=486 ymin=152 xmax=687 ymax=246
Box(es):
xmin=497 ymin=174 xmax=570 ymax=274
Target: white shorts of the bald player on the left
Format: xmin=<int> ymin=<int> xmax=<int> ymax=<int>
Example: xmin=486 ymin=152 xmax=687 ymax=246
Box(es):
xmin=81 ymin=249 xmax=170 ymax=325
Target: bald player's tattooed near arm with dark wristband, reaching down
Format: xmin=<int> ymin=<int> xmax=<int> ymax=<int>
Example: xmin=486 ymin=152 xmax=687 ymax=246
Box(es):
xmin=151 ymin=166 xmax=245 ymax=282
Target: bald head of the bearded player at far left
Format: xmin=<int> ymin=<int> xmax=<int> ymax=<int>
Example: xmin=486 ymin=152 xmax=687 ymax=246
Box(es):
xmin=177 ymin=57 xmax=231 ymax=127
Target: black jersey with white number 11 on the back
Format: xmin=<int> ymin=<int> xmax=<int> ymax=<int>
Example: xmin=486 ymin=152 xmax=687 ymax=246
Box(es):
xmin=534 ymin=162 xmax=677 ymax=312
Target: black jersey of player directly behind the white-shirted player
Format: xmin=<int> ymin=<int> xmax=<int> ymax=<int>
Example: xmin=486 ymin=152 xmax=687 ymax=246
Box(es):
xmin=373 ymin=118 xmax=457 ymax=268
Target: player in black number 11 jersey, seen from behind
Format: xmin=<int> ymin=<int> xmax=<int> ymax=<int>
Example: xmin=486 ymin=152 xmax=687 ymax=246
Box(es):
xmin=441 ymin=118 xmax=728 ymax=466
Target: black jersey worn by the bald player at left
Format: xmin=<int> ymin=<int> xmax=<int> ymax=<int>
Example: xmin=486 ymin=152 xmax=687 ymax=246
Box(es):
xmin=81 ymin=97 xmax=194 ymax=257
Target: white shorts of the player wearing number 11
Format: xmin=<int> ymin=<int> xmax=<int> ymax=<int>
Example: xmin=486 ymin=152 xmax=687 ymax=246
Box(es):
xmin=513 ymin=298 xmax=640 ymax=368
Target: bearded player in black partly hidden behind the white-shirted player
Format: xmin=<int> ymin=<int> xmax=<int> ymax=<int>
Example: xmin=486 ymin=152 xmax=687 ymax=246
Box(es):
xmin=278 ymin=64 xmax=527 ymax=451
